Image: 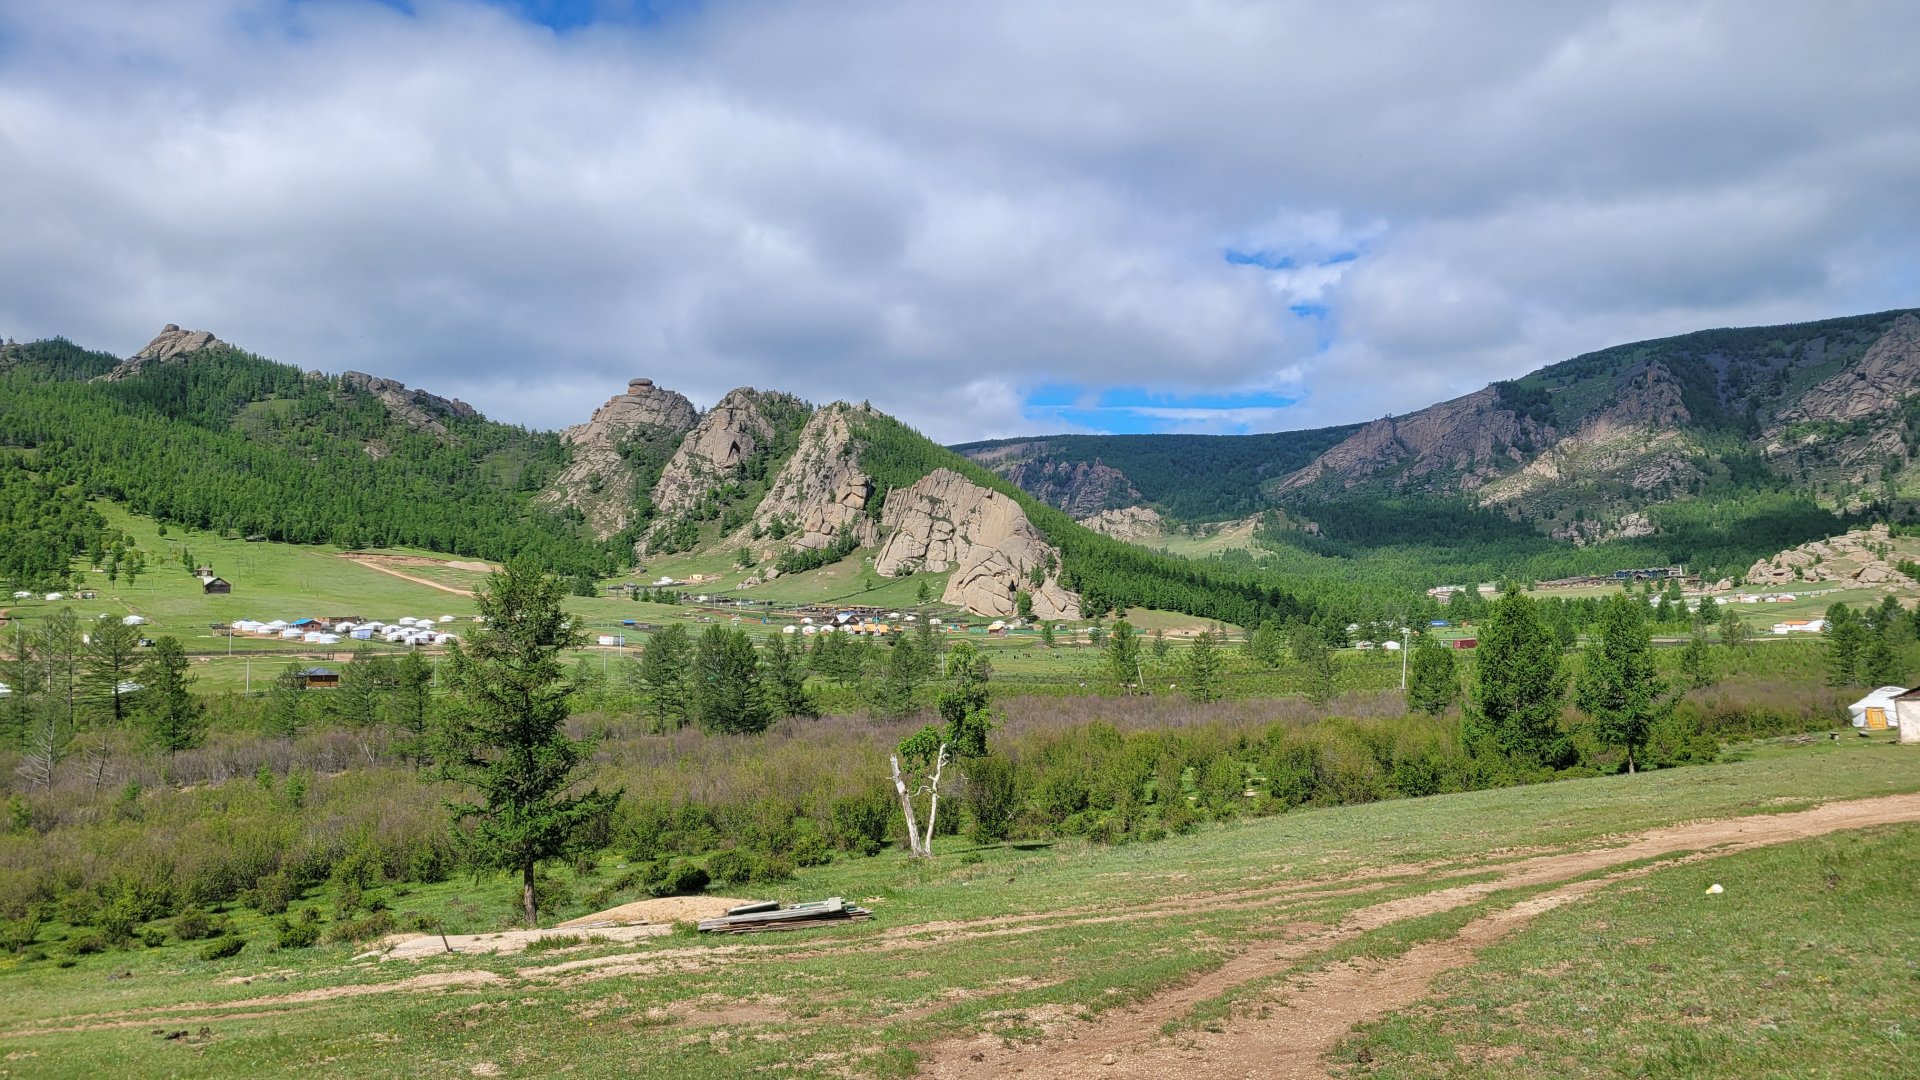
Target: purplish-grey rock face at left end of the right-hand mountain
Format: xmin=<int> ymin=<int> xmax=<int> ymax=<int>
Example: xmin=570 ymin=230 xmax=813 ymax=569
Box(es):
xmin=1281 ymin=386 xmax=1553 ymax=492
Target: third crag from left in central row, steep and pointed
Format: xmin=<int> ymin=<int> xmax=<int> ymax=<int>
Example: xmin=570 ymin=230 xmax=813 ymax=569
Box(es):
xmin=728 ymin=402 xmax=879 ymax=550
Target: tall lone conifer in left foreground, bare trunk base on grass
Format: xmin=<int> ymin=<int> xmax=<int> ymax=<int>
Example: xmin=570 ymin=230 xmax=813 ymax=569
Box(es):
xmin=438 ymin=559 xmax=618 ymax=926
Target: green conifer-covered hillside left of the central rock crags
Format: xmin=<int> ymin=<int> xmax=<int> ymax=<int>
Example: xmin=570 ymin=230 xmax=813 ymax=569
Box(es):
xmin=0 ymin=340 xmax=618 ymax=573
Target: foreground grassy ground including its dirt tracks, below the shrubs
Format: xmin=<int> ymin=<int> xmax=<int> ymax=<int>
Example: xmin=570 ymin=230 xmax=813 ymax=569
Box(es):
xmin=0 ymin=740 xmax=1920 ymax=1080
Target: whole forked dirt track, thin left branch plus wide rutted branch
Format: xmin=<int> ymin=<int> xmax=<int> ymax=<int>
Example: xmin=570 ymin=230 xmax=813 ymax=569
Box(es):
xmin=15 ymin=794 xmax=1920 ymax=1045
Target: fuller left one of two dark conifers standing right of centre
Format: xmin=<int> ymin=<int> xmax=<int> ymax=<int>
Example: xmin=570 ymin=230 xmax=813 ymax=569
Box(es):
xmin=1461 ymin=590 xmax=1567 ymax=767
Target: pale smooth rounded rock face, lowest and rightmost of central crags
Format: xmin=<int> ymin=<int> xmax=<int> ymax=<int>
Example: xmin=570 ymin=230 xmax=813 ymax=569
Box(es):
xmin=874 ymin=469 xmax=1079 ymax=619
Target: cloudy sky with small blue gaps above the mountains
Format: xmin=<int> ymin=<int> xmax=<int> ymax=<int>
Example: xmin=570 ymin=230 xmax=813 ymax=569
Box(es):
xmin=0 ymin=0 xmax=1920 ymax=442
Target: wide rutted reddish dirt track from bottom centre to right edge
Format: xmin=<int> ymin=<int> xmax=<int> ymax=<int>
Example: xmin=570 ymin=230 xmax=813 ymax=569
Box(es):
xmin=922 ymin=796 xmax=1920 ymax=1078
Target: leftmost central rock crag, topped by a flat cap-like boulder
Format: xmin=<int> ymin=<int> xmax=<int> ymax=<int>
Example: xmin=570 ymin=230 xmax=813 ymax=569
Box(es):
xmin=540 ymin=379 xmax=693 ymax=540
